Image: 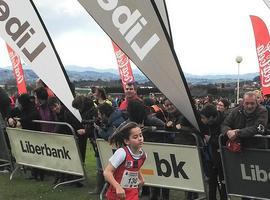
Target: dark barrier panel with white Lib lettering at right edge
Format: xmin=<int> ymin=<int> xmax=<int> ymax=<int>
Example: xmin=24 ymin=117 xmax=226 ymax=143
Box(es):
xmin=219 ymin=135 xmax=270 ymax=200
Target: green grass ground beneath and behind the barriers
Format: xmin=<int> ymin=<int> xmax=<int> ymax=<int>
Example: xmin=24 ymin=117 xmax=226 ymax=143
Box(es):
xmin=0 ymin=145 xmax=240 ymax=200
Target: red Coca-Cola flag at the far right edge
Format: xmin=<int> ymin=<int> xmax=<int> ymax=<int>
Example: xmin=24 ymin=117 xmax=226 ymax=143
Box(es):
xmin=250 ymin=15 xmax=270 ymax=95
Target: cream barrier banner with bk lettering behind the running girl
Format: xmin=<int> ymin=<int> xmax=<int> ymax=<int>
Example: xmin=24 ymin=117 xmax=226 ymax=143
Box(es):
xmin=97 ymin=139 xmax=205 ymax=192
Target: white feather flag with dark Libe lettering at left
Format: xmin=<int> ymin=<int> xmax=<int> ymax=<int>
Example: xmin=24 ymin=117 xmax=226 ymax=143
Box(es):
xmin=0 ymin=0 xmax=81 ymax=120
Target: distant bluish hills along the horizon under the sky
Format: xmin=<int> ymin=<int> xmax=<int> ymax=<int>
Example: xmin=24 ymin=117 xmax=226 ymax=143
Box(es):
xmin=0 ymin=65 xmax=259 ymax=84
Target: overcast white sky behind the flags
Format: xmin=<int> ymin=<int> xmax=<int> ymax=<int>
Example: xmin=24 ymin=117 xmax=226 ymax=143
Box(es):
xmin=0 ymin=0 xmax=270 ymax=74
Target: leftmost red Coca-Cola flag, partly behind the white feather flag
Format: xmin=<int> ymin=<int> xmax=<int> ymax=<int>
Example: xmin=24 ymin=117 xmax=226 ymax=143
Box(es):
xmin=6 ymin=44 xmax=27 ymax=94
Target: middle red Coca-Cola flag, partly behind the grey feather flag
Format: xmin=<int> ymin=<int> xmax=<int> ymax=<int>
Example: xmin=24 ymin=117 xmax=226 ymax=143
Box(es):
xmin=112 ymin=41 xmax=135 ymax=90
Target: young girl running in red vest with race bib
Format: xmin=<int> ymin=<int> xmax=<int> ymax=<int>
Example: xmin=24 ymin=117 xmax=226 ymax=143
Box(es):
xmin=104 ymin=122 xmax=146 ymax=200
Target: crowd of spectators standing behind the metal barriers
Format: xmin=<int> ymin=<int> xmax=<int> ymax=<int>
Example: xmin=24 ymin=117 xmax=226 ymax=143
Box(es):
xmin=0 ymin=80 xmax=270 ymax=200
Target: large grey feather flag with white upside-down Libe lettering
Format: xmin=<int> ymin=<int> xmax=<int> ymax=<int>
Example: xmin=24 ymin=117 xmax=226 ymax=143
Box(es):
xmin=79 ymin=0 xmax=199 ymax=129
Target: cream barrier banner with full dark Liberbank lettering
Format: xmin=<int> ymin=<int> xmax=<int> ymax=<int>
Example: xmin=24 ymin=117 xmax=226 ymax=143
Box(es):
xmin=7 ymin=128 xmax=84 ymax=176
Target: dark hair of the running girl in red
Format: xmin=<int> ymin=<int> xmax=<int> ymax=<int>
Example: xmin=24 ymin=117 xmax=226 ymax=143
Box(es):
xmin=109 ymin=122 xmax=139 ymax=147
